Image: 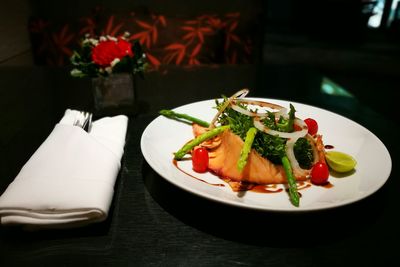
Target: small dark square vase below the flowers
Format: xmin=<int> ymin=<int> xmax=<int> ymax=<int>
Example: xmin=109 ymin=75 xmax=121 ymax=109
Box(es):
xmin=92 ymin=73 xmax=136 ymax=115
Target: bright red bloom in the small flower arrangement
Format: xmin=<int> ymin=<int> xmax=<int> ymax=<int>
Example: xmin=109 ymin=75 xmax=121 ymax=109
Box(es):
xmin=92 ymin=39 xmax=133 ymax=67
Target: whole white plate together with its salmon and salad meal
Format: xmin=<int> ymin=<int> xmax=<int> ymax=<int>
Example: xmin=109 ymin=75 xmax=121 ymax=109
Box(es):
xmin=141 ymin=89 xmax=391 ymax=210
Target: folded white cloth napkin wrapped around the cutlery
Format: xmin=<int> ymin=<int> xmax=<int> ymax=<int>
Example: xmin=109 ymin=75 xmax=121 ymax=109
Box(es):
xmin=0 ymin=110 xmax=128 ymax=228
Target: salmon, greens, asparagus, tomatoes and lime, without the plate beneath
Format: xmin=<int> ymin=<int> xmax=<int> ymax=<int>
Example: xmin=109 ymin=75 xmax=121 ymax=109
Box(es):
xmin=160 ymin=89 xmax=356 ymax=207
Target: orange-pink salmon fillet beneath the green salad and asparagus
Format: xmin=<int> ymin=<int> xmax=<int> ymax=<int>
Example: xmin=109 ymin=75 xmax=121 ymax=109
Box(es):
xmin=193 ymin=124 xmax=306 ymax=184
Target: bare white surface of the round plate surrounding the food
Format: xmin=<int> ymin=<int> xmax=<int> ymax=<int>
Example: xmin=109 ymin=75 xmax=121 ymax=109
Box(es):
xmin=140 ymin=98 xmax=392 ymax=211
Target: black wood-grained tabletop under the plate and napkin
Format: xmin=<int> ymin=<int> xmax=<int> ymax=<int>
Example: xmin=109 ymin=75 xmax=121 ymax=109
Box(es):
xmin=0 ymin=65 xmax=400 ymax=266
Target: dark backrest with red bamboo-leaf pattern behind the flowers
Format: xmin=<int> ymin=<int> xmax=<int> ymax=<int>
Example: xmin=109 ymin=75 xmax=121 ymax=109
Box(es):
xmin=29 ymin=8 xmax=253 ymax=69
